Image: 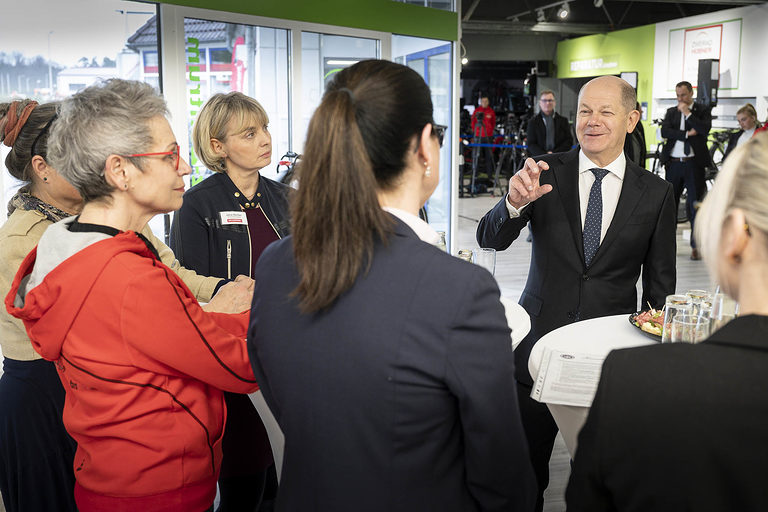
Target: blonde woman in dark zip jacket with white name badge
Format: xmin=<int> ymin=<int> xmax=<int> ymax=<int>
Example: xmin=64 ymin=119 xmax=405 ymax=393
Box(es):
xmin=171 ymin=92 xmax=289 ymax=512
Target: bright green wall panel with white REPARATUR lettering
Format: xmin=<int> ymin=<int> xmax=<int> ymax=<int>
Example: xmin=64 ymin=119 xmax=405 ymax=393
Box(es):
xmin=556 ymin=25 xmax=656 ymax=144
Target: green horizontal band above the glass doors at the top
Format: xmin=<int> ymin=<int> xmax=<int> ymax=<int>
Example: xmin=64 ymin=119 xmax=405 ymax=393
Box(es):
xmin=156 ymin=0 xmax=459 ymax=41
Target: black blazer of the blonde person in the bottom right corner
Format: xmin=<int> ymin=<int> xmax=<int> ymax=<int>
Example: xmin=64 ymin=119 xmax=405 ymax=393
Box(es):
xmin=566 ymin=315 xmax=768 ymax=512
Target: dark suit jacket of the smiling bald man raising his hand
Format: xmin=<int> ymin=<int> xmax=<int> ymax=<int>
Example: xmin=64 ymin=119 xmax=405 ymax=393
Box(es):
xmin=477 ymin=149 xmax=677 ymax=385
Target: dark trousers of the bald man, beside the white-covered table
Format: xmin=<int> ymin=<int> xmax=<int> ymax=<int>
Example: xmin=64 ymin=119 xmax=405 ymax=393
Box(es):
xmin=517 ymin=382 xmax=558 ymax=512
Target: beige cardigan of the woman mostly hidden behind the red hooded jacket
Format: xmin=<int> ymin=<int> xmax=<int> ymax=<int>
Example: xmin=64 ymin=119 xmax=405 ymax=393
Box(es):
xmin=0 ymin=209 xmax=221 ymax=361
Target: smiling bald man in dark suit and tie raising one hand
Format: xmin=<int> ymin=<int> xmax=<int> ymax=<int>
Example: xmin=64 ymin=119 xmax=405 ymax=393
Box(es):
xmin=477 ymin=76 xmax=676 ymax=510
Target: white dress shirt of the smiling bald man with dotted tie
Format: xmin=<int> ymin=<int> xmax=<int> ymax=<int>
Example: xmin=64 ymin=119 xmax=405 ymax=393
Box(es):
xmin=504 ymin=150 xmax=627 ymax=242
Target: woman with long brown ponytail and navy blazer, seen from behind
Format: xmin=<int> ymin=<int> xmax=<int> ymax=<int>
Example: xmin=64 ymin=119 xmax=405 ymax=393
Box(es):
xmin=248 ymin=60 xmax=535 ymax=512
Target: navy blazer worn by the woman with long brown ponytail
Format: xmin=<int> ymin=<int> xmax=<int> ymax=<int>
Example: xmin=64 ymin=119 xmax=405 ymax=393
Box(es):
xmin=248 ymin=217 xmax=536 ymax=512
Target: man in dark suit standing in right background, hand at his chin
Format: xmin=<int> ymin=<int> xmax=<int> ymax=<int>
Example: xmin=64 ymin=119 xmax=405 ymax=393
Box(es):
xmin=661 ymin=82 xmax=712 ymax=260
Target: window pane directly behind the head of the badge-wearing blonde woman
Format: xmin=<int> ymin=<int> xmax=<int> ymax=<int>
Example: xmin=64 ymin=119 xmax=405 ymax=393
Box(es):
xmin=184 ymin=18 xmax=290 ymax=189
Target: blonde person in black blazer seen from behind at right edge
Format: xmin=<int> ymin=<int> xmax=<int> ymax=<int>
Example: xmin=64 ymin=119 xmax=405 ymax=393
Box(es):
xmin=566 ymin=134 xmax=768 ymax=512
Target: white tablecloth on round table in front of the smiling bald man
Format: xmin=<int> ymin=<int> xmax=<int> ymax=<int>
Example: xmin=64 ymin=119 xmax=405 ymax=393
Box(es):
xmin=528 ymin=314 xmax=654 ymax=458
